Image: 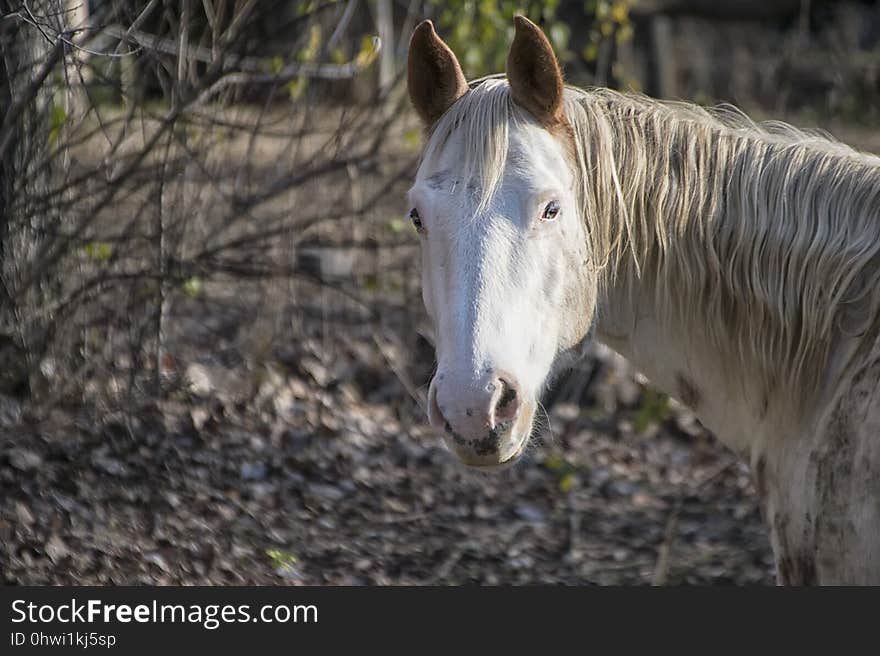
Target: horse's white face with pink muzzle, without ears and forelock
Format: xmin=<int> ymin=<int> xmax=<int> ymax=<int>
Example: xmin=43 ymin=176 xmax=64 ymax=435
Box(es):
xmin=409 ymin=120 xmax=595 ymax=467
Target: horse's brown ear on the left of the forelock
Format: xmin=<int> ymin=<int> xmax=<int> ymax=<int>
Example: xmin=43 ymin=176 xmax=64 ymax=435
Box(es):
xmin=407 ymin=20 xmax=468 ymax=127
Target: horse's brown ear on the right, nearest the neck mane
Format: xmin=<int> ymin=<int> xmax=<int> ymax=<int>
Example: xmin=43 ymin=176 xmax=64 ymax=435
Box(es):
xmin=507 ymin=16 xmax=565 ymax=127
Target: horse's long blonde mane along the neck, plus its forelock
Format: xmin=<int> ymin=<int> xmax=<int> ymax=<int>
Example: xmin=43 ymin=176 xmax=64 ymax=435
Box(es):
xmin=424 ymin=78 xmax=880 ymax=416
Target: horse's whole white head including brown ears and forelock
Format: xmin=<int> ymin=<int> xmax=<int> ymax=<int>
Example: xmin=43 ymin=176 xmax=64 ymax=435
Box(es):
xmin=408 ymin=16 xmax=596 ymax=468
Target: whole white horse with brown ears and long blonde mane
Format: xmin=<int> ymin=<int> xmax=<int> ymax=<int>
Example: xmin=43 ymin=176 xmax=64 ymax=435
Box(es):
xmin=407 ymin=16 xmax=880 ymax=584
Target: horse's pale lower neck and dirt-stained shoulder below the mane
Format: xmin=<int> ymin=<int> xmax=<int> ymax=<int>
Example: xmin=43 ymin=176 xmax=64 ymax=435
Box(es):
xmin=596 ymin=222 xmax=880 ymax=584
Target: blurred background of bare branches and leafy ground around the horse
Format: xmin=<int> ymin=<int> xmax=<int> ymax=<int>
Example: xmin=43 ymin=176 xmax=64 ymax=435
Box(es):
xmin=0 ymin=0 xmax=880 ymax=585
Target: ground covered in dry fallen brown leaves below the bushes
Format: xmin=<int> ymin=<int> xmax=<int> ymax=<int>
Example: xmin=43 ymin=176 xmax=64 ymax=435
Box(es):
xmin=0 ymin=334 xmax=774 ymax=585
